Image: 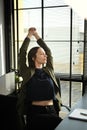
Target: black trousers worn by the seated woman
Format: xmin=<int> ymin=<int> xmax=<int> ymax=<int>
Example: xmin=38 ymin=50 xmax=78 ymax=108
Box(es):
xmin=26 ymin=105 xmax=62 ymax=130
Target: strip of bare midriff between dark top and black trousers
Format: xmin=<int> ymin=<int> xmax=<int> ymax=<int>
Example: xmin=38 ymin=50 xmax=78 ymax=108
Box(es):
xmin=32 ymin=100 xmax=53 ymax=106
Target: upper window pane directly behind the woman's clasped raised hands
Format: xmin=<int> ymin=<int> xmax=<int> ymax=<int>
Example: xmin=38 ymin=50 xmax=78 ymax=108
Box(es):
xmin=18 ymin=9 xmax=41 ymax=40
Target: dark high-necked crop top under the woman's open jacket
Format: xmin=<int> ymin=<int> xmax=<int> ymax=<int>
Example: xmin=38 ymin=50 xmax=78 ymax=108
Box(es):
xmin=26 ymin=69 xmax=55 ymax=101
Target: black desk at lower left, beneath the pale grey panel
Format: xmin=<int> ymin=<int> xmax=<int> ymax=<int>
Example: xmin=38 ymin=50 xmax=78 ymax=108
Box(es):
xmin=0 ymin=95 xmax=17 ymax=130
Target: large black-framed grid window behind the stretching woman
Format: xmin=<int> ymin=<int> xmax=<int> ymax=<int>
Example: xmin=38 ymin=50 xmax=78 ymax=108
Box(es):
xmin=14 ymin=0 xmax=84 ymax=106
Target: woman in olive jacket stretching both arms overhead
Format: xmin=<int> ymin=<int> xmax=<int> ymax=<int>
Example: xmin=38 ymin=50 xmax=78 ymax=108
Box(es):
xmin=17 ymin=27 xmax=62 ymax=130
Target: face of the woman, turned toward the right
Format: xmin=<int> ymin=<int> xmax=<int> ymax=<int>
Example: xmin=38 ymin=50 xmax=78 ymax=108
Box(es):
xmin=34 ymin=47 xmax=47 ymax=64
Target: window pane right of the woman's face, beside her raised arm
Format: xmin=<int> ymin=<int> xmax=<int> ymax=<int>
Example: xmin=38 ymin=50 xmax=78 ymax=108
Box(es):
xmin=46 ymin=42 xmax=70 ymax=73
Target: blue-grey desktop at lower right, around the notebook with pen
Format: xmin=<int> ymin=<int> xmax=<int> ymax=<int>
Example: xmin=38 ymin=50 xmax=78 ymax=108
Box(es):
xmin=55 ymin=94 xmax=87 ymax=130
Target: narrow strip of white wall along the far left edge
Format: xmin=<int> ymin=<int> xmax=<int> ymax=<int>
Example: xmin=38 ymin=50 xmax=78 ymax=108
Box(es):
xmin=0 ymin=0 xmax=5 ymax=76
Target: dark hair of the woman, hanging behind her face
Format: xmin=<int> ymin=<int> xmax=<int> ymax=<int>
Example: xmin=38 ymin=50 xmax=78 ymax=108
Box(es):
xmin=28 ymin=47 xmax=40 ymax=67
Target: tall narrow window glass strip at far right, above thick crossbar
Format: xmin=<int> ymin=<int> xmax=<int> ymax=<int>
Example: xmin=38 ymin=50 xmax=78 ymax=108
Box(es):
xmin=72 ymin=12 xmax=84 ymax=74
